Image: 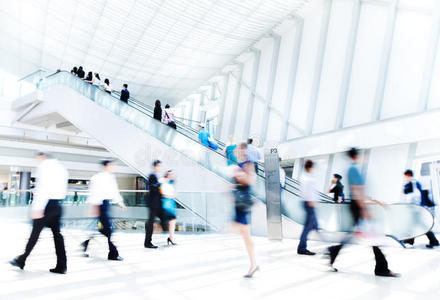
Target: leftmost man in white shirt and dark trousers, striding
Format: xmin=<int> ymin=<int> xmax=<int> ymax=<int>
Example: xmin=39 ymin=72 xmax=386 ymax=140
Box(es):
xmin=10 ymin=153 xmax=69 ymax=274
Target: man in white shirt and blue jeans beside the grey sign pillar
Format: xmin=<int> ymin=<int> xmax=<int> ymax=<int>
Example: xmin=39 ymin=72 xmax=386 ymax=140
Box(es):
xmin=297 ymin=160 xmax=318 ymax=255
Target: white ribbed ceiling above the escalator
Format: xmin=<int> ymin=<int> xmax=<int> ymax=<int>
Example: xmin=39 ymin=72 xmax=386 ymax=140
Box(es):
xmin=0 ymin=0 xmax=311 ymax=103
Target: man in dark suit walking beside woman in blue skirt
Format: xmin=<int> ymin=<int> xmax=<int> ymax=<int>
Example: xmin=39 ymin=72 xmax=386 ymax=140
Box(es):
xmin=144 ymin=160 xmax=165 ymax=249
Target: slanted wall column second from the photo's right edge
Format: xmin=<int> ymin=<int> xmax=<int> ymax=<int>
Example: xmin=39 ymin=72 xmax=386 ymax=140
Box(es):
xmin=371 ymin=0 xmax=397 ymax=121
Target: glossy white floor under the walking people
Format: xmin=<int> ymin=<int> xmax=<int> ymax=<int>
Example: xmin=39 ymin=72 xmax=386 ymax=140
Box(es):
xmin=0 ymin=222 xmax=440 ymax=300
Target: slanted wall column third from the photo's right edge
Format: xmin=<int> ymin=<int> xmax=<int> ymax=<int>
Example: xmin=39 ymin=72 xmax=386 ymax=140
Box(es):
xmin=335 ymin=0 xmax=361 ymax=129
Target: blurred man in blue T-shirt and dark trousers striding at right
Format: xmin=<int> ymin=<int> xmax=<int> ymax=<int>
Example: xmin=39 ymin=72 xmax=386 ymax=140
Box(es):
xmin=328 ymin=148 xmax=399 ymax=277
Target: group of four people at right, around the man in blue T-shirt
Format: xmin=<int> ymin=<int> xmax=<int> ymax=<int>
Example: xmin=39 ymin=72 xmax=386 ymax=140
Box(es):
xmin=297 ymin=148 xmax=439 ymax=277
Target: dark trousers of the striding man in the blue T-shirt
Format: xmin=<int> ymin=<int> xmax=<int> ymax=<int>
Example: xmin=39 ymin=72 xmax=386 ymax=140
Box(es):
xmin=329 ymin=202 xmax=390 ymax=274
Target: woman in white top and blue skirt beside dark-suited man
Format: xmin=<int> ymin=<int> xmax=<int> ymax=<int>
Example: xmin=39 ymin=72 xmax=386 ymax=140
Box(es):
xmin=160 ymin=170 xmax=177 ymax=245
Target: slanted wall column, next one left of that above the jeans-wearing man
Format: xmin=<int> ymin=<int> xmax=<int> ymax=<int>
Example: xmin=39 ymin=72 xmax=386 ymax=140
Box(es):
xmin=281 ymin=18 xmax=304 ymax=142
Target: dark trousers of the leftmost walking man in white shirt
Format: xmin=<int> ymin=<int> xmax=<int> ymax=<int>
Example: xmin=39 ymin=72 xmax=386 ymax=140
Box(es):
xmin=17 ymin=200 xmax=67 ymax=269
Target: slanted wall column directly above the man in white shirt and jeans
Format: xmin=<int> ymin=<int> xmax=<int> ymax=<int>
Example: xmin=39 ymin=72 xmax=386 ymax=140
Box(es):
xmin=306 ymin=0 xmax=333 ymax=135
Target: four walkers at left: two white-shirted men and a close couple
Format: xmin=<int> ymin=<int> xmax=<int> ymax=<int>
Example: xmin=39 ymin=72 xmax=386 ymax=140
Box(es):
xmin=10 ymin=153 xmax=177 ymax=274
